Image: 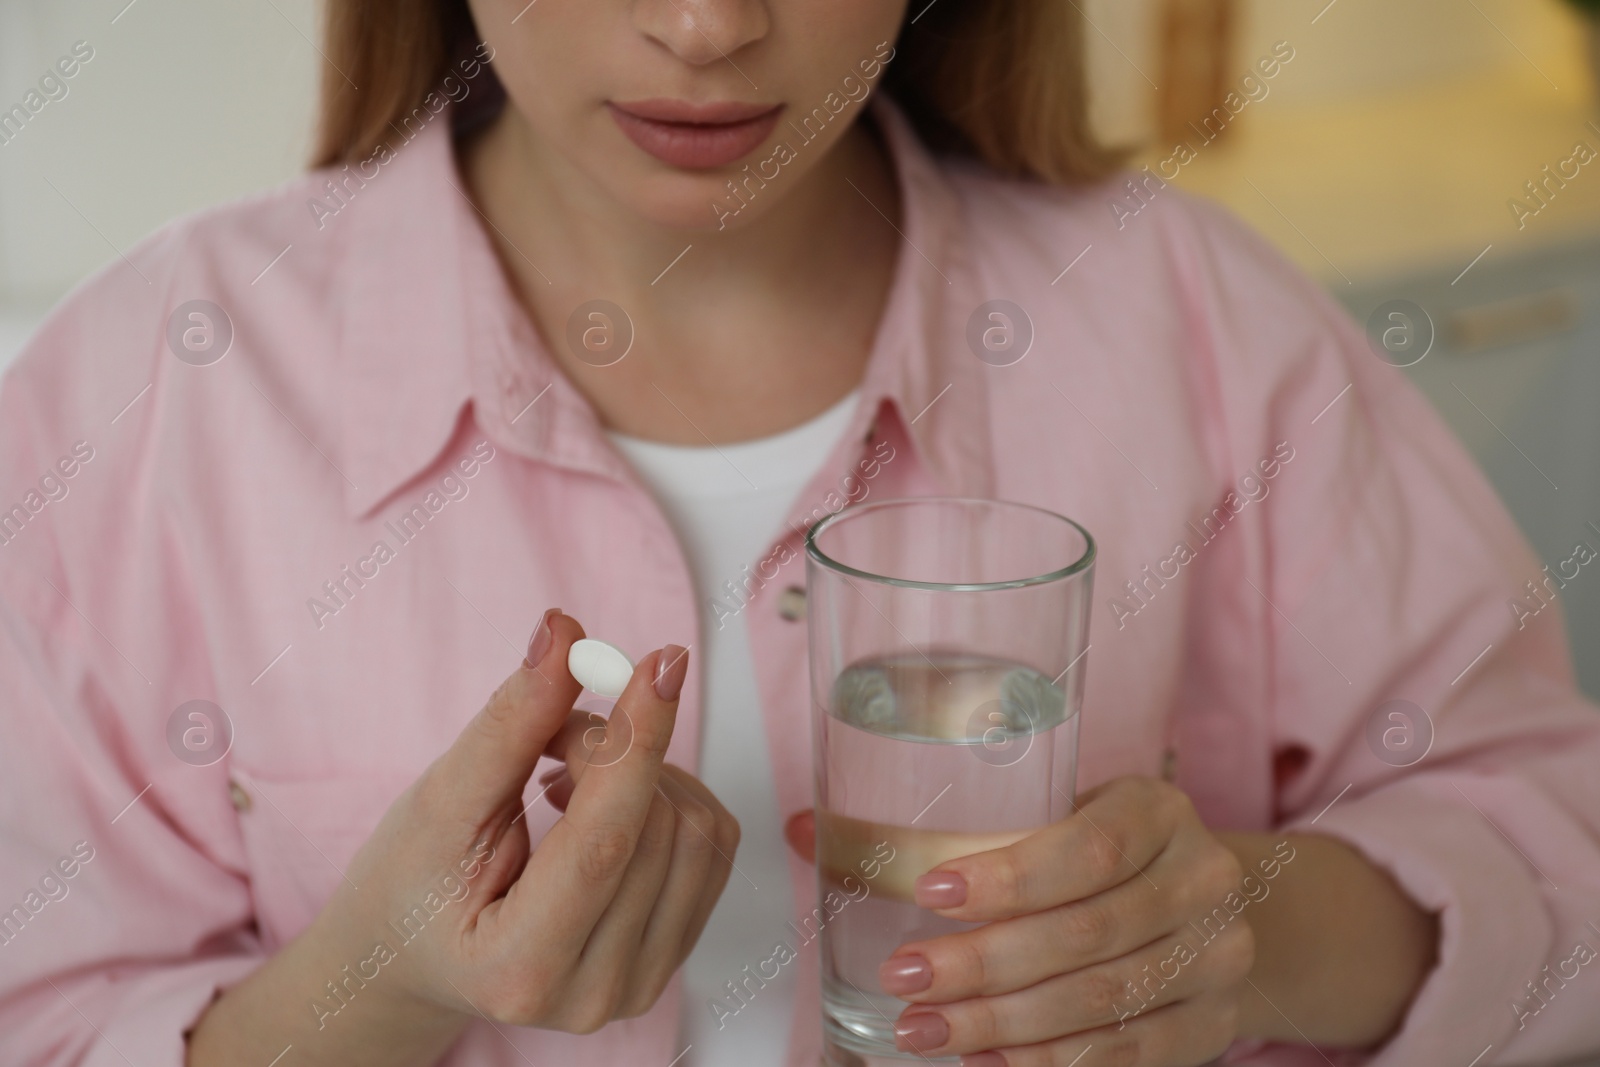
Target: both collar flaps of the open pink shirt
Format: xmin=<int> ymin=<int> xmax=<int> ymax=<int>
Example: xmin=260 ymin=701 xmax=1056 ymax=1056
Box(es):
xmin=328 ymin=94 xmax=994 ymax=517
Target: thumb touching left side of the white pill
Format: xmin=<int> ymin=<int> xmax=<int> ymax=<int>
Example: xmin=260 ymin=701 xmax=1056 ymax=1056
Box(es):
xmin=435 ymin=608 xmax=584 ymax=814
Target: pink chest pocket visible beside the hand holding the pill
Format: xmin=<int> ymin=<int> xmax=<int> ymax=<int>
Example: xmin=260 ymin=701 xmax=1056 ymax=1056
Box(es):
xmin=232 ymin=765 xmax=416 ymax=949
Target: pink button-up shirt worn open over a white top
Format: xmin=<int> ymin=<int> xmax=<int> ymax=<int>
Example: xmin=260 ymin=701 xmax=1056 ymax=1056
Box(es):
xmin=0 ymin=101 xmax=1600 ymax=1067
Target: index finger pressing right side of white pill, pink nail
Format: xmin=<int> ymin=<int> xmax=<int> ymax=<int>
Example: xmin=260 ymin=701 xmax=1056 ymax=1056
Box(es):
xmin=506 ymin=645 xmax=688 ymax=944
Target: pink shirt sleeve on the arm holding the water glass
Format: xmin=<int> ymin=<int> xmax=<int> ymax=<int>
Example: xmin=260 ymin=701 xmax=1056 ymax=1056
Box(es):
xmin=1178 ymin=195 xmax=1600 ymax=1067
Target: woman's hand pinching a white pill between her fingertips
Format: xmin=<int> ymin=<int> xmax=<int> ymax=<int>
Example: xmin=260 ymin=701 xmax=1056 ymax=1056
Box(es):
xmin=190 ymin=608 xmax=739 ymax=1064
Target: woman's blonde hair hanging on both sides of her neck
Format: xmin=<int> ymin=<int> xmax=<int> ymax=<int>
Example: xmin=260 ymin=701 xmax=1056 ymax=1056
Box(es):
xmin=310 ymin=0 xmax=1125 ymax=186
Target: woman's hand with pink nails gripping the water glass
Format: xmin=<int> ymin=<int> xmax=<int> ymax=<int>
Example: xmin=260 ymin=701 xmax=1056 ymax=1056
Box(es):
xmin=880 ymin=777 xmax=1254 ymax=1067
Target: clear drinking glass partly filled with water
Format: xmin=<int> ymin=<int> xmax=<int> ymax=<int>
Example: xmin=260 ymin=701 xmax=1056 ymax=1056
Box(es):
xmin=800 ymin=498 xmax=1094 ymax=1067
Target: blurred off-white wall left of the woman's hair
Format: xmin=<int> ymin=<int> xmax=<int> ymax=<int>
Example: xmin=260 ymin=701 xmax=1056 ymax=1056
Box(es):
xmin=0 ymin=0 xmax=322 ymax=308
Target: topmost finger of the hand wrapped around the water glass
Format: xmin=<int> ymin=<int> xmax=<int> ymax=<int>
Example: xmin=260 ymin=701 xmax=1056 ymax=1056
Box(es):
xmin=917 ymin=777 xmax=1189 ymax=923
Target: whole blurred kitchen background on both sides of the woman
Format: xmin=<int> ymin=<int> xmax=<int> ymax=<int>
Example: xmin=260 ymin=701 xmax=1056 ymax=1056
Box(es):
xmin=0 ymin=0 xmax=1600 ymax=697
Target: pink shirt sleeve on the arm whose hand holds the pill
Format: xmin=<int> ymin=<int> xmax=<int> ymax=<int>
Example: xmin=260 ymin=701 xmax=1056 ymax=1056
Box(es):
xmin=0 ymin=255 xmax=272 ymax=1067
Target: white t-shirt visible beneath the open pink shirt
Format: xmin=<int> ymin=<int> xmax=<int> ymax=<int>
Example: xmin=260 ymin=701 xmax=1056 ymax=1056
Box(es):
xmin=608 ymin=390 xmax=859 ymax=1067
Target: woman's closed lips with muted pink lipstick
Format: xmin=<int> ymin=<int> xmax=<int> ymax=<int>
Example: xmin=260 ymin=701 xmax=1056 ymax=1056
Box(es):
xmin=606 ymin=101 xmax=782 ymax=170
